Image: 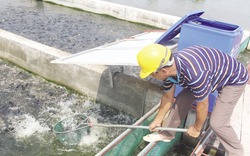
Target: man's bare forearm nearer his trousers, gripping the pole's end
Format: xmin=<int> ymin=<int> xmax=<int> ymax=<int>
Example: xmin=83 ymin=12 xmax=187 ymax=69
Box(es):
xmin=187 ymin=97 xmax=208 ymax=138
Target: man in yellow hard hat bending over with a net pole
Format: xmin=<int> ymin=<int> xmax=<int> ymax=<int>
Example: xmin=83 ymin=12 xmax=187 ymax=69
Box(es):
xmin=137 ymin=44 xmax=248 ymax=156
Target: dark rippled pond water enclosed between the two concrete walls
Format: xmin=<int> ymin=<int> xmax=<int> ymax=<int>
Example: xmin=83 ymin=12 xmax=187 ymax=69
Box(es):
xmin=0 ymin=0 xmax=152 ymax=53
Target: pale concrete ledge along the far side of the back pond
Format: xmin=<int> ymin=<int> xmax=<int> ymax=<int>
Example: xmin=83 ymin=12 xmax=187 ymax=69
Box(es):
xmin=44 ymin=0 xmax=179 ymax=29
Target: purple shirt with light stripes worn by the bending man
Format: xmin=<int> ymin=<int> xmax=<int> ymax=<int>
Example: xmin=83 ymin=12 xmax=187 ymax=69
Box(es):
xmin=164 ymin=46 xmax=248 ymax=102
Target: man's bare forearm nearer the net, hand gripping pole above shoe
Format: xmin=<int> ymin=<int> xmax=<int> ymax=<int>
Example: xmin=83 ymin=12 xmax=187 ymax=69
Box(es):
xmin=149 ymin=85 xmax=175 ymax=131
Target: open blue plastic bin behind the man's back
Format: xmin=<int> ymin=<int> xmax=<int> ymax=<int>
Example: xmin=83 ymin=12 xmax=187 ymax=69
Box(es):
xmin=177 ymin=18 xmax=243 ymax=57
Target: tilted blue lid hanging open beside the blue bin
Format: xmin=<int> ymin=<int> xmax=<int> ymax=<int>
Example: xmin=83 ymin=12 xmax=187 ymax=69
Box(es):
xmin=155 ymin=11 xmax=204 ymax=45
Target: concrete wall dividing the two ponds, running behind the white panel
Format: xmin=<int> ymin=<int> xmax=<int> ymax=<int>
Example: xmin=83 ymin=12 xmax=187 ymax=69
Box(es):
xmin=0 ymin=30 xmax=161 ymax=117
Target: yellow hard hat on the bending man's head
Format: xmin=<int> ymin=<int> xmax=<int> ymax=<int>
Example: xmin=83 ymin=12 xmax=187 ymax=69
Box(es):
xmin=137 ymin=43 xmax=171 ymax=78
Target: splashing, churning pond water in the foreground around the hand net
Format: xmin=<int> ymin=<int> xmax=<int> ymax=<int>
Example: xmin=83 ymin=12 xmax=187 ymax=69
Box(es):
xmin=0 ymin=60 xmax=135 ymax=156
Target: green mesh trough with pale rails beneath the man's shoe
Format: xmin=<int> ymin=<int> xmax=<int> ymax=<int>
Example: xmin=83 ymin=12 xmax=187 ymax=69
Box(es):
xmin=96 ymin=105 xmax=186 ymax=156
